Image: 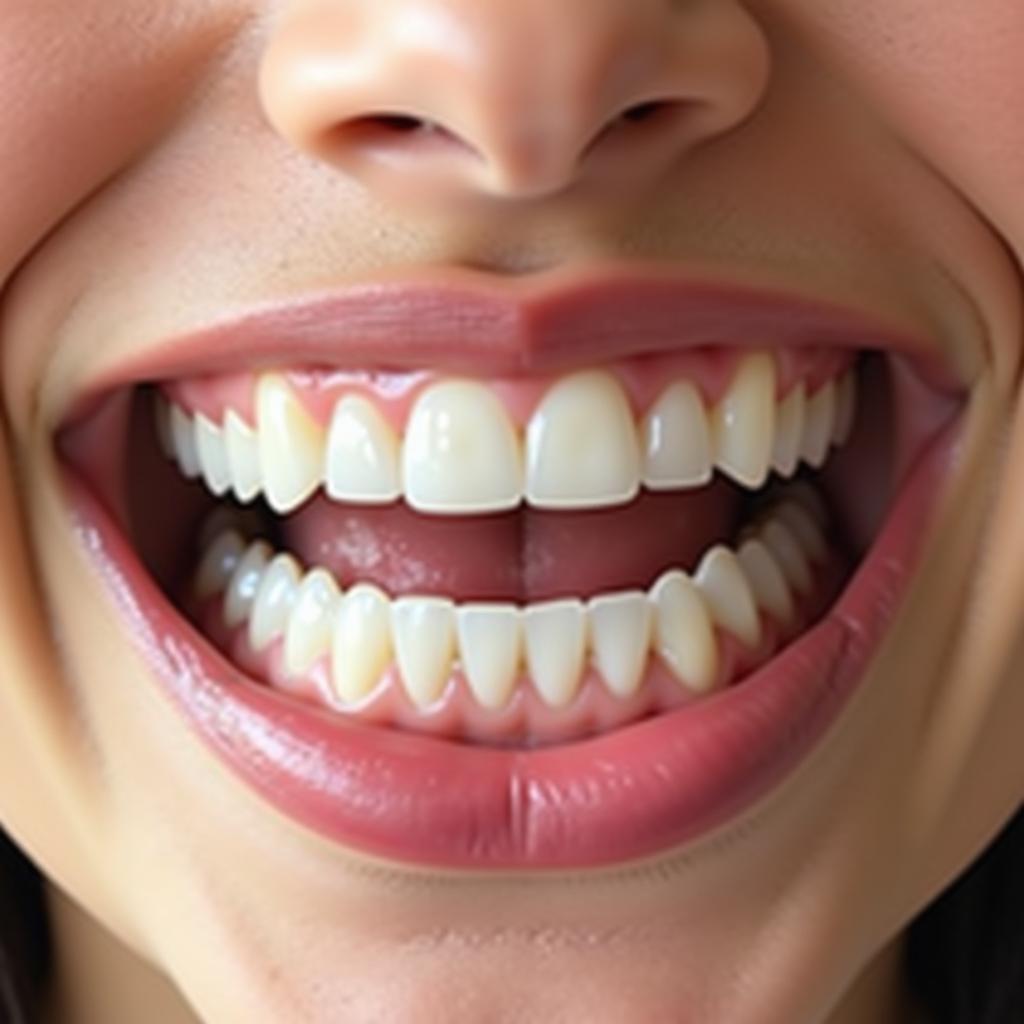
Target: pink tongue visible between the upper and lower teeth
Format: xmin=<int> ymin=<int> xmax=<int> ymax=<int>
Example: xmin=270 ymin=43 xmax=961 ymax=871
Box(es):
xmin=282 ymin=478 xmax=742 ymax=603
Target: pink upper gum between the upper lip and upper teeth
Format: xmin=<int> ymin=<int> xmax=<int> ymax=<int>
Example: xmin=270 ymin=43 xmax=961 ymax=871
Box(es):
xmin=163 ymin=347 xmax=856 ymax=434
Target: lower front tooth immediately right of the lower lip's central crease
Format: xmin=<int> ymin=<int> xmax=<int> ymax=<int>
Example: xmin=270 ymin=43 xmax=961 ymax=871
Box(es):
xmin=523 ymin=600 xmax=587 ymax=708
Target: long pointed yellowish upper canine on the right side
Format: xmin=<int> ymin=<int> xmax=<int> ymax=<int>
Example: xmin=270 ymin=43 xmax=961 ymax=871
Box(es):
xmin=712 ymin=352 xmax=775 ymax=487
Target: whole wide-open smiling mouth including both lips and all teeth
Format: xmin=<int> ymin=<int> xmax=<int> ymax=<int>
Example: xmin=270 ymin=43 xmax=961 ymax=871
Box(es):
xmin=57 ymin=268 xmax=962 ymax=869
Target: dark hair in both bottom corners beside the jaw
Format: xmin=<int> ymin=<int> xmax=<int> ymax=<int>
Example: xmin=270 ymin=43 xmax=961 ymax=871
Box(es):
xmin=0 ymin=810 xmax=1024 ymax=1024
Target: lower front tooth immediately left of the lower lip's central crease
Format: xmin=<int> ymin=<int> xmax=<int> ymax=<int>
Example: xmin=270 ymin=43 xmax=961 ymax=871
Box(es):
xmin=456 ymin=604 xmax=522 ymax=711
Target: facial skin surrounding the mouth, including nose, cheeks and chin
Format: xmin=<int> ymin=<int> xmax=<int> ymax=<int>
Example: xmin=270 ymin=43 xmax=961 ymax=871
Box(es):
xmin=0 ymin=0 xmax=1024 ymax=1024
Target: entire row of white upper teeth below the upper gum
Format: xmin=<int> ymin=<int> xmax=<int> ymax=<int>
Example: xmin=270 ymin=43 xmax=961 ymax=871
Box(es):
xmin=158 ymin=352 xmax=855 ymax=514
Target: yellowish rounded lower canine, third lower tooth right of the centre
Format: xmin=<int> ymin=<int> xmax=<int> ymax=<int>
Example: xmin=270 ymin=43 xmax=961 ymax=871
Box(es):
xmin=650 ymin=569 xmax=718 ymax=693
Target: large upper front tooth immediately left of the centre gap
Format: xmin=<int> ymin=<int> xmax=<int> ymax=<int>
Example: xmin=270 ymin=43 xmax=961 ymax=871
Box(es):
xmin=402 ymin=381 xmax=522 ymax=513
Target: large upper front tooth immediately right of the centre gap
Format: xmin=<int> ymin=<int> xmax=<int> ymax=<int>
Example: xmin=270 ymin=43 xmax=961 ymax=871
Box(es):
xmin=526 ymin=370 xmax=640 ymax=508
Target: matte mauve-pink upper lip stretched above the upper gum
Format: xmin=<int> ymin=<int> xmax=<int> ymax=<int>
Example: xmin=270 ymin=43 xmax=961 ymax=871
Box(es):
xmin=81 ymin=256 xmax=956 ymax=393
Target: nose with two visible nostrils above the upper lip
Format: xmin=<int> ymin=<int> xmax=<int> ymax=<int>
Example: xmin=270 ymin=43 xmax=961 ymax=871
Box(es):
xmin=259 ymin=0 xmax=770 ymax=205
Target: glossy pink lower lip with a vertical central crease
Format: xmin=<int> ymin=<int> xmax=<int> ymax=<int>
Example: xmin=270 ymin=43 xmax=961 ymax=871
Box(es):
xmin=61 ymin=429 xmax=954 ymax=869
